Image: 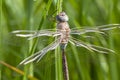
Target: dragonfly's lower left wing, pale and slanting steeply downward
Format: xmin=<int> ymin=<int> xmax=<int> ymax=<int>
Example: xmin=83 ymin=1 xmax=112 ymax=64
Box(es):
xmin=20 ymin=38 xmax=60 ymax=65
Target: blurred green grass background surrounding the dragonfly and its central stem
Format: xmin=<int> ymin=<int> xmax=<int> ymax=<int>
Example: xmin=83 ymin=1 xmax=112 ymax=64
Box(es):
xmin=0 ymin=0 xmax=120 ymax=80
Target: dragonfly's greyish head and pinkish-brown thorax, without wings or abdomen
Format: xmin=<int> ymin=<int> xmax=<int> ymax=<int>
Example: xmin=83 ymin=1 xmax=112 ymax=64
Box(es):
xmin=57 ymin=12 xmax=70 ymax=44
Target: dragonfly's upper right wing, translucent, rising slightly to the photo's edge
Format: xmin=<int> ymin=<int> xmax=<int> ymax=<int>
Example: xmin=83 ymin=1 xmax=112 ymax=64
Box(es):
xmin=70 ymin=24 xmax=120 ymax=35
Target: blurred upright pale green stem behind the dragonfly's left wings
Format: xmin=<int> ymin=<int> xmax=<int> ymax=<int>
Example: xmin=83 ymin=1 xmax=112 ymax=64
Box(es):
xmin=23 ymin=0 xmax=34 ymax=80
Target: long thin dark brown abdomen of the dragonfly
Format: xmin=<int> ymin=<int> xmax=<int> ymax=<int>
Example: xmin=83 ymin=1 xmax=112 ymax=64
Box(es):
xmin=62 ymin=49 xmax=69 ymax=80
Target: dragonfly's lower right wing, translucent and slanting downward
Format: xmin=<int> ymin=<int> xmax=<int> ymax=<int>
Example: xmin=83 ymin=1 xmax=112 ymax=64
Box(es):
xmin=69 ymin=37 xmax=114 ymax=53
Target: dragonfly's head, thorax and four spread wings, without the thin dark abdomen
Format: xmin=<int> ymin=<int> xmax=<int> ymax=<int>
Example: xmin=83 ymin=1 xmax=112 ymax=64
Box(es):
xmin=12 ymin=12 xmax=120 ymax=65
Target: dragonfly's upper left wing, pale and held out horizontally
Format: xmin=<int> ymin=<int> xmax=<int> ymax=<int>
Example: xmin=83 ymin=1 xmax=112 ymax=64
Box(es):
xmin=12 ymin=29 xmax=60 ymax=40
